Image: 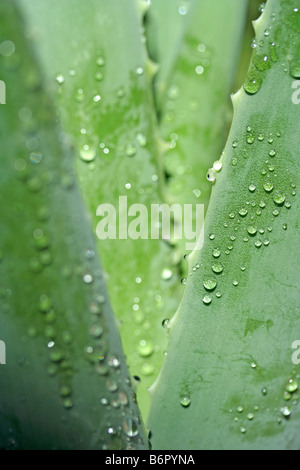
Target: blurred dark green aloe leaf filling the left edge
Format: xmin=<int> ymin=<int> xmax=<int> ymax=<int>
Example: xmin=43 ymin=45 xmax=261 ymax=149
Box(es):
xmin=0 ymin=0 xmax=147 ymax=449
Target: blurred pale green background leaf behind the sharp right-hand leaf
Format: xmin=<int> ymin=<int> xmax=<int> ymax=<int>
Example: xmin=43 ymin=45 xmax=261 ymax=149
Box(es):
xmin=160 ymin=0 xmax=248 ymax=260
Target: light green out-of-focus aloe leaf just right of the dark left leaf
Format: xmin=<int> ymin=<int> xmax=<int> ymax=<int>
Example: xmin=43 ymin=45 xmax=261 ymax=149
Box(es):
xmin=19 ymin=0 xmax=181 ymax=415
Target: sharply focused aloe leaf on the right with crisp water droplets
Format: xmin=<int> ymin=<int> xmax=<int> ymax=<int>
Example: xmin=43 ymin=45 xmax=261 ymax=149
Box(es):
xmin=149 ymin=0 xmax=300 ymax=450
